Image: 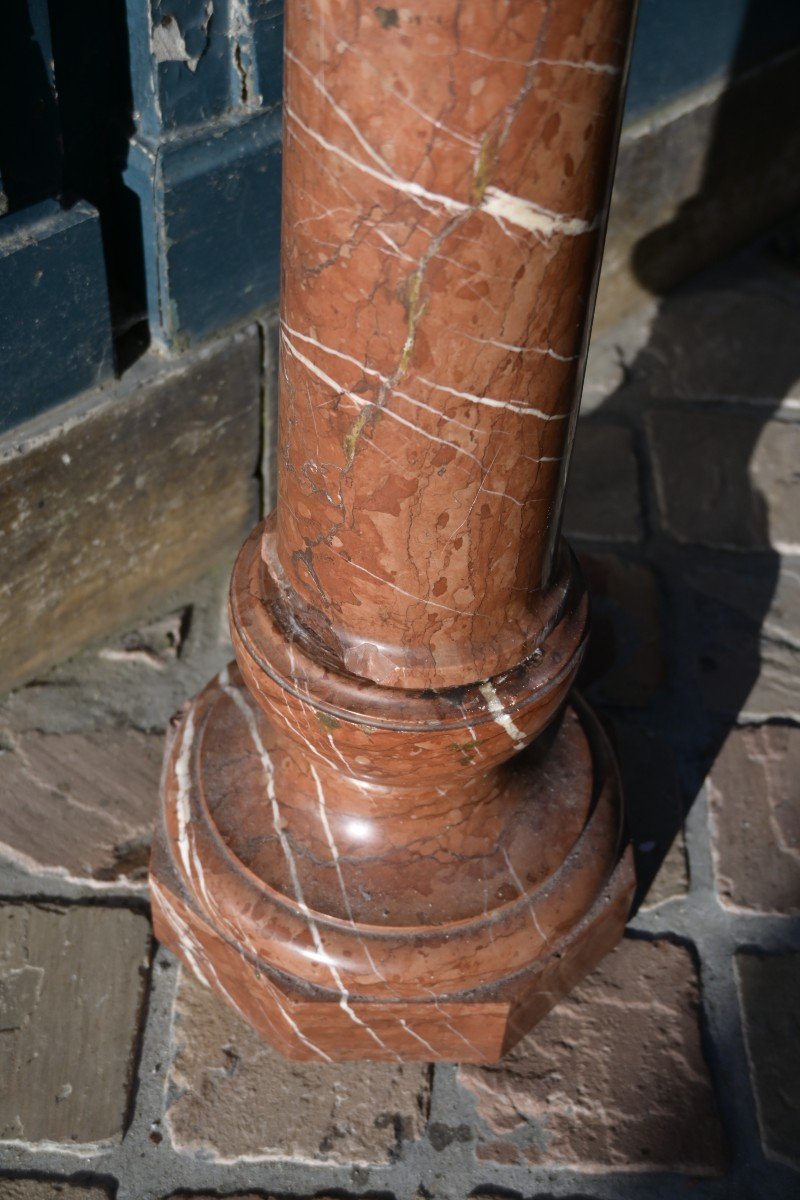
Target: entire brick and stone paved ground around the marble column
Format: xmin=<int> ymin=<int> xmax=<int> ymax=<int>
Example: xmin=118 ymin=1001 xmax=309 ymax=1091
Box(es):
xmin=0 ymin=229 xmax=800 ymax=1200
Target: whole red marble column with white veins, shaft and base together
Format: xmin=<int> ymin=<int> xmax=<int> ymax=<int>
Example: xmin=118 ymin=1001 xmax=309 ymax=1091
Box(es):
xmin=151 ymin=0 xmax=633 ymax=1062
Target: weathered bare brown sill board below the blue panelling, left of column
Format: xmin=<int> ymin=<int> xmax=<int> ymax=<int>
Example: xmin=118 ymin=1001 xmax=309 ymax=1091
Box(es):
xmin=0 ymin=328 xmax=260 ymax=688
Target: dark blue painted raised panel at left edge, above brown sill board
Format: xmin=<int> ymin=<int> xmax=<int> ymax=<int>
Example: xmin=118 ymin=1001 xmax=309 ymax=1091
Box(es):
xmin=0 ymin=200 xmax=113 ymax=430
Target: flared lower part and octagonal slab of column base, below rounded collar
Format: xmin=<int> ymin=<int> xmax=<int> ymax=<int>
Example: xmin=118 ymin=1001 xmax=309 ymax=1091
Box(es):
xmin=151 ymin=667 xmax=633 ymax=1063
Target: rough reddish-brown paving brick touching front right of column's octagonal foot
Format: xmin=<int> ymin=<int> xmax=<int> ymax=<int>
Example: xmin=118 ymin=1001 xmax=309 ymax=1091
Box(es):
xmin=458 ymin=940 xmax=724 ymax=1175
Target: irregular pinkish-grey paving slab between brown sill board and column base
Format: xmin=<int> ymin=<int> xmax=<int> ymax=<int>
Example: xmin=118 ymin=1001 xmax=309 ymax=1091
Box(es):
xmin=0 ymin=569 xmax=233 ymax=895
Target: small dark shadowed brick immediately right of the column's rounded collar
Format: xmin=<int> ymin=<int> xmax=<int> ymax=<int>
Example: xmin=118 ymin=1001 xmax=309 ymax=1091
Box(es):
xmin=579 ymin=554 xmax=664 ymax=707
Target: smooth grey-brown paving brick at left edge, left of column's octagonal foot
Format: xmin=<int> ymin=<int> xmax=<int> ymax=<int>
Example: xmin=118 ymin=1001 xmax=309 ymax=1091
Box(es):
xmin=0 ymin=904 xmax=150 ymax=1142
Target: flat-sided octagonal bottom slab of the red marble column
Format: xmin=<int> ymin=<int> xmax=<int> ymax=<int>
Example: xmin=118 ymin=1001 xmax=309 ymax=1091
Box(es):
xmin=151 ymin=851 xmax=633 ymax=1063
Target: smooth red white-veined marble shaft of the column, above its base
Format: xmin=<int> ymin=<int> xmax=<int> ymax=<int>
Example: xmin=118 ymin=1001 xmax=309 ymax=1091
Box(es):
xmin=275 ymin=0 xmax=632 ymax=688
